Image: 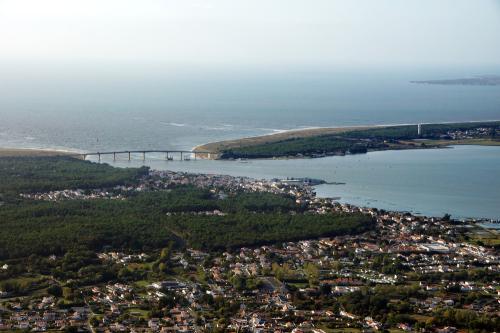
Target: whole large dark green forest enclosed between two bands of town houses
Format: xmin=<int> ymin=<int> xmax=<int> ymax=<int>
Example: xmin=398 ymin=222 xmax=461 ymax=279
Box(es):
xmin=0 ymin=187 xmax=372 ymax=258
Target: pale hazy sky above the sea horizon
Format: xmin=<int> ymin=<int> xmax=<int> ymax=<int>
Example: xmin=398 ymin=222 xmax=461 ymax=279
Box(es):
xmin=0 ymin=0 xmax=500 ymax=67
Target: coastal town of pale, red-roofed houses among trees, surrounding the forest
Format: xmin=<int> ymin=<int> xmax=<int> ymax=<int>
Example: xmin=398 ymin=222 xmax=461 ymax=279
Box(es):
xmin=0 ymin=170 xmax=500 ymax=333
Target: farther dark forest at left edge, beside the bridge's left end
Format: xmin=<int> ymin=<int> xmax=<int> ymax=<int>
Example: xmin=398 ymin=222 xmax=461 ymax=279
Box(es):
xmin=0 ymin=157 xmax=148 ymax=199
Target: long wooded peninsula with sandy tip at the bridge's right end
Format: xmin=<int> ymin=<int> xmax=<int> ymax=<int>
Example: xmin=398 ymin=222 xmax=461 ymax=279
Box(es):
xmin=194 ymin=121 xmax=500 ymax=159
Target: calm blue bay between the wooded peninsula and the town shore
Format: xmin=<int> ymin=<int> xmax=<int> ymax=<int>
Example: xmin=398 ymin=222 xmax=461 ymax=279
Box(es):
xmin=92 ymin=146 xmax=500 ymax=219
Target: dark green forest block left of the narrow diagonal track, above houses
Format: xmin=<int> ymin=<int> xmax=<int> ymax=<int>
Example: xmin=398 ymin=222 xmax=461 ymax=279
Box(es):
xmin=0 ymin=200 xmax=179 ymax=258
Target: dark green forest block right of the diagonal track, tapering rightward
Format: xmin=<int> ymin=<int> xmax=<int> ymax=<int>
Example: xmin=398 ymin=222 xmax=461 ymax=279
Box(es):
xmin=170 ymin=212 xmax=374 ymax=250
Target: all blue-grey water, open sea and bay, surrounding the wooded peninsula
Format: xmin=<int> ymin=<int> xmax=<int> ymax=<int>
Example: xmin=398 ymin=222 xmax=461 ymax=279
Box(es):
xmin=0 ymin=68 xmax=500 ymax=218
